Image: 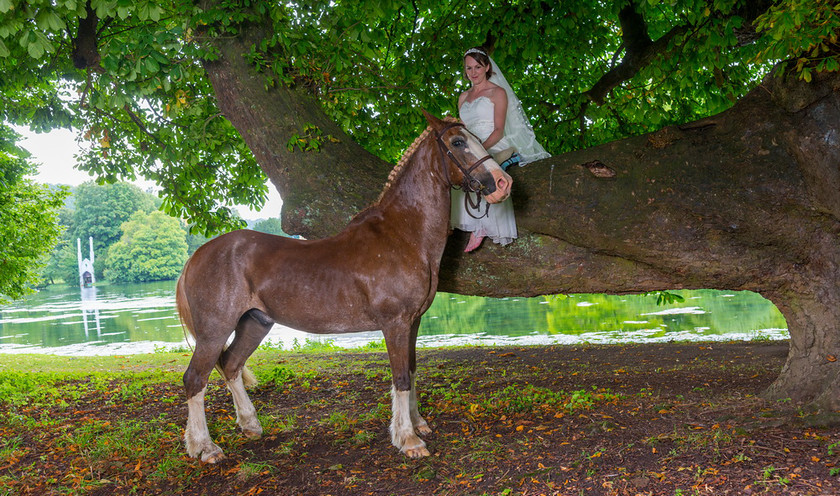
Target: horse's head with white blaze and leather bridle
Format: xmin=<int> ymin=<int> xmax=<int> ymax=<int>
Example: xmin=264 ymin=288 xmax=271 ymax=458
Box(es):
xmin=423 ymin=110 xmax=513 ymax=203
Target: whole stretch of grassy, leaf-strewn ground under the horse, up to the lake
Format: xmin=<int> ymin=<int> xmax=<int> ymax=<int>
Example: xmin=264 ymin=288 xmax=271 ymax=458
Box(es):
xmin=0 ymin=345 xmax=840 ymax=495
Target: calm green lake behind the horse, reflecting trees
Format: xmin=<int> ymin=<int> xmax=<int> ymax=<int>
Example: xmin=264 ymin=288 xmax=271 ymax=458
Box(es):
xmin=0 ymin=281 xmax=788 ymax=356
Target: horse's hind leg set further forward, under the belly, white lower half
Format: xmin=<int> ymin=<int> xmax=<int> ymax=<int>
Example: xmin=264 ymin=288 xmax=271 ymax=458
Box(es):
xmin=219 ymin=310 xmax=274 ymax=439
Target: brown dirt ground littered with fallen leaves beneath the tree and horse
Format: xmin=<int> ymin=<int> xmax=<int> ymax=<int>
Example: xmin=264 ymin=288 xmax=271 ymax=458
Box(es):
xmin=0 ymin=342 xmax=840 ymax=496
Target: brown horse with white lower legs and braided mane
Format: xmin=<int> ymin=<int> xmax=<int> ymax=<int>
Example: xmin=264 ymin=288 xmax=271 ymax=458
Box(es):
xmin=176 ymin=114 xmax=512 ymax=462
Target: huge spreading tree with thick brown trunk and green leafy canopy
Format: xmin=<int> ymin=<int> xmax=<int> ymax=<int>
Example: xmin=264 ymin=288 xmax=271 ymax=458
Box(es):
xmin=0 ymin=0 xmax=840 ymax=409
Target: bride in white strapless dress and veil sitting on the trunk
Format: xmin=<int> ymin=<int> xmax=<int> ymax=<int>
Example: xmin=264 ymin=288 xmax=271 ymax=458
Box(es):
xmin=451 ymin=48 xmax=550 ymax=252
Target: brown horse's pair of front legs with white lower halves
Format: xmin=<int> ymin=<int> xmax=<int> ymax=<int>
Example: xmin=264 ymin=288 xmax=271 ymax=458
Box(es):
xmin=383 ymin=325 xmax=429 ymax=458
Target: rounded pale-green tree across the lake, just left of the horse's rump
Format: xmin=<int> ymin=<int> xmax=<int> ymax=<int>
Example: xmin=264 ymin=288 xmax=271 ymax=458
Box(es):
xmin=105 ymin=210 xmax=187 ymax=283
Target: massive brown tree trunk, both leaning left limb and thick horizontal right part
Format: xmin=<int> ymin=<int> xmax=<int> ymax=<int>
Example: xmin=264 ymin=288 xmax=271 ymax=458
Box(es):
xmin=207 ymin=16 xmax=840 ymax=409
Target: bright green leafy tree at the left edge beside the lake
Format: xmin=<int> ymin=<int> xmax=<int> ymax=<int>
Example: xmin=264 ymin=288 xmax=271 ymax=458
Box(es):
xmin=0 ymin=126 xmax=67 ymax=304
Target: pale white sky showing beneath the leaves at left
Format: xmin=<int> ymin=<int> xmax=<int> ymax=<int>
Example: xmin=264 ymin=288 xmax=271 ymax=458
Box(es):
xmin=15 ymin=127 xmax=283 ymax=220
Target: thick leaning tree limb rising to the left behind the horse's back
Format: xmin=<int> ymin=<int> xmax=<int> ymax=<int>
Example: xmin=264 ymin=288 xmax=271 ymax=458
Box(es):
xmin=202 ymin=1 xmax=392 ymax=237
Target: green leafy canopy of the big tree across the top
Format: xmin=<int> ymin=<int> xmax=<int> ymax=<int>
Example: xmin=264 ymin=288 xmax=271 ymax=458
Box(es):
xmin=0 ymin=0 xmax=840 ymax=231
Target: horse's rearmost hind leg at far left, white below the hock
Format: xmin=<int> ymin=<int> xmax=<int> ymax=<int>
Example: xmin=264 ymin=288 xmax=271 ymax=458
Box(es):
xmin=184 ymin=336 xmax=227 ymax=463
